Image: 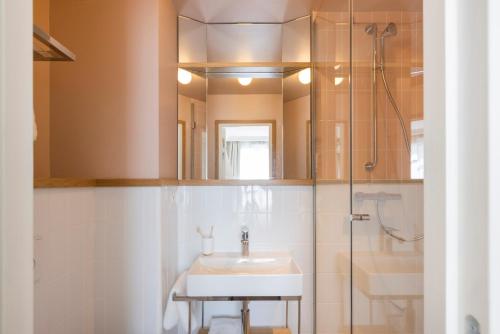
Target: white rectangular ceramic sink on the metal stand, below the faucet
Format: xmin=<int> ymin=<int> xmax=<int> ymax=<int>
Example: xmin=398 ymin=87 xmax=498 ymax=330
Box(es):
xmin=186 ymin=252 xmax=303 ymax=297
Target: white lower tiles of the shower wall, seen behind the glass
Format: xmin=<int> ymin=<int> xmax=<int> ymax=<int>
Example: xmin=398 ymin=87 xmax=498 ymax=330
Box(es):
xmin=316 ymin=184 xmax=423 ymax=334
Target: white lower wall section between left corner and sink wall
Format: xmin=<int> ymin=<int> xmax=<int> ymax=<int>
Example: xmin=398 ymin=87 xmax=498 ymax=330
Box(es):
xmin=95 ymin=187 xmax=162 ymax=334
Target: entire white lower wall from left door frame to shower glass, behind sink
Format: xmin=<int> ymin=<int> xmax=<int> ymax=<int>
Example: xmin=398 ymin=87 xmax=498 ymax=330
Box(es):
xmin=35 ymin=187 xmax=313 ymax=334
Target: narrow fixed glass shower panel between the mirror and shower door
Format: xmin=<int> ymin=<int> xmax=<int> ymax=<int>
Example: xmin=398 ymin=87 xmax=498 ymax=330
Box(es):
xmin=313 ymin=0 xmax=351 ymax=334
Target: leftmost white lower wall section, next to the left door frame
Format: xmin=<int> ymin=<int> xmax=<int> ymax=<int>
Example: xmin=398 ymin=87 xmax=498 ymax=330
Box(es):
xmin=34 ymin=189 xmax=95 ymax=334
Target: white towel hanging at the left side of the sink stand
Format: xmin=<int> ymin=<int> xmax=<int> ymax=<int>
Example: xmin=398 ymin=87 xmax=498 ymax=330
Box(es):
xmin=163 ymin=272 xmax=198 ymax=334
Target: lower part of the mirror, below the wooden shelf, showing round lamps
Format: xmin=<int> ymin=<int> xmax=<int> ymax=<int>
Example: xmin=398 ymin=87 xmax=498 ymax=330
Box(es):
xmin=178 ymin=68 xmax=311 ymax=180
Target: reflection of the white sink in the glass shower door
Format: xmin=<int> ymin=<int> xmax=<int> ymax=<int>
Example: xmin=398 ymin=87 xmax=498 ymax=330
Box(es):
xmin=339 ymin=252 xmax=424 ymax=298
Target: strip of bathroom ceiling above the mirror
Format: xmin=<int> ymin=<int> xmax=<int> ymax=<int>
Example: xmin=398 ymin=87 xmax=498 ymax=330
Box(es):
xmin=173 ymin=0 xmax=317 ymax=23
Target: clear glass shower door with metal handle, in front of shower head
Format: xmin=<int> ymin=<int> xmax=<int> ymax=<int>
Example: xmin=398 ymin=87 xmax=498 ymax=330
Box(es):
xmin=350 ymin=0 xmax=424 ymax=334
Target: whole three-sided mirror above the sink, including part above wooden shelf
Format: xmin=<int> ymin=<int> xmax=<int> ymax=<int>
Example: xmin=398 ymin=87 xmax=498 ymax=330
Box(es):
xmin=178 ymin=16 xmax=311 ymax=180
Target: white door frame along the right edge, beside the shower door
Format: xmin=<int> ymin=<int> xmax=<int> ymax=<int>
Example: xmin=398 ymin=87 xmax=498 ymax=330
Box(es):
xmin=424 ymin=0 xmax=500 ymax=334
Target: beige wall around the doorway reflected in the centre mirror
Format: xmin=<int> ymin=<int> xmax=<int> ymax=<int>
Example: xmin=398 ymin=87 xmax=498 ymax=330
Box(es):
xmin=207 ymin=94 xmax=283 ymax=178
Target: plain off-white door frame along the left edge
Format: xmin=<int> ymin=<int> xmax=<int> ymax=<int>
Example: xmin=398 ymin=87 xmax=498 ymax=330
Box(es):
xmin=0 ymin=0 xmax=33 ymax=334
